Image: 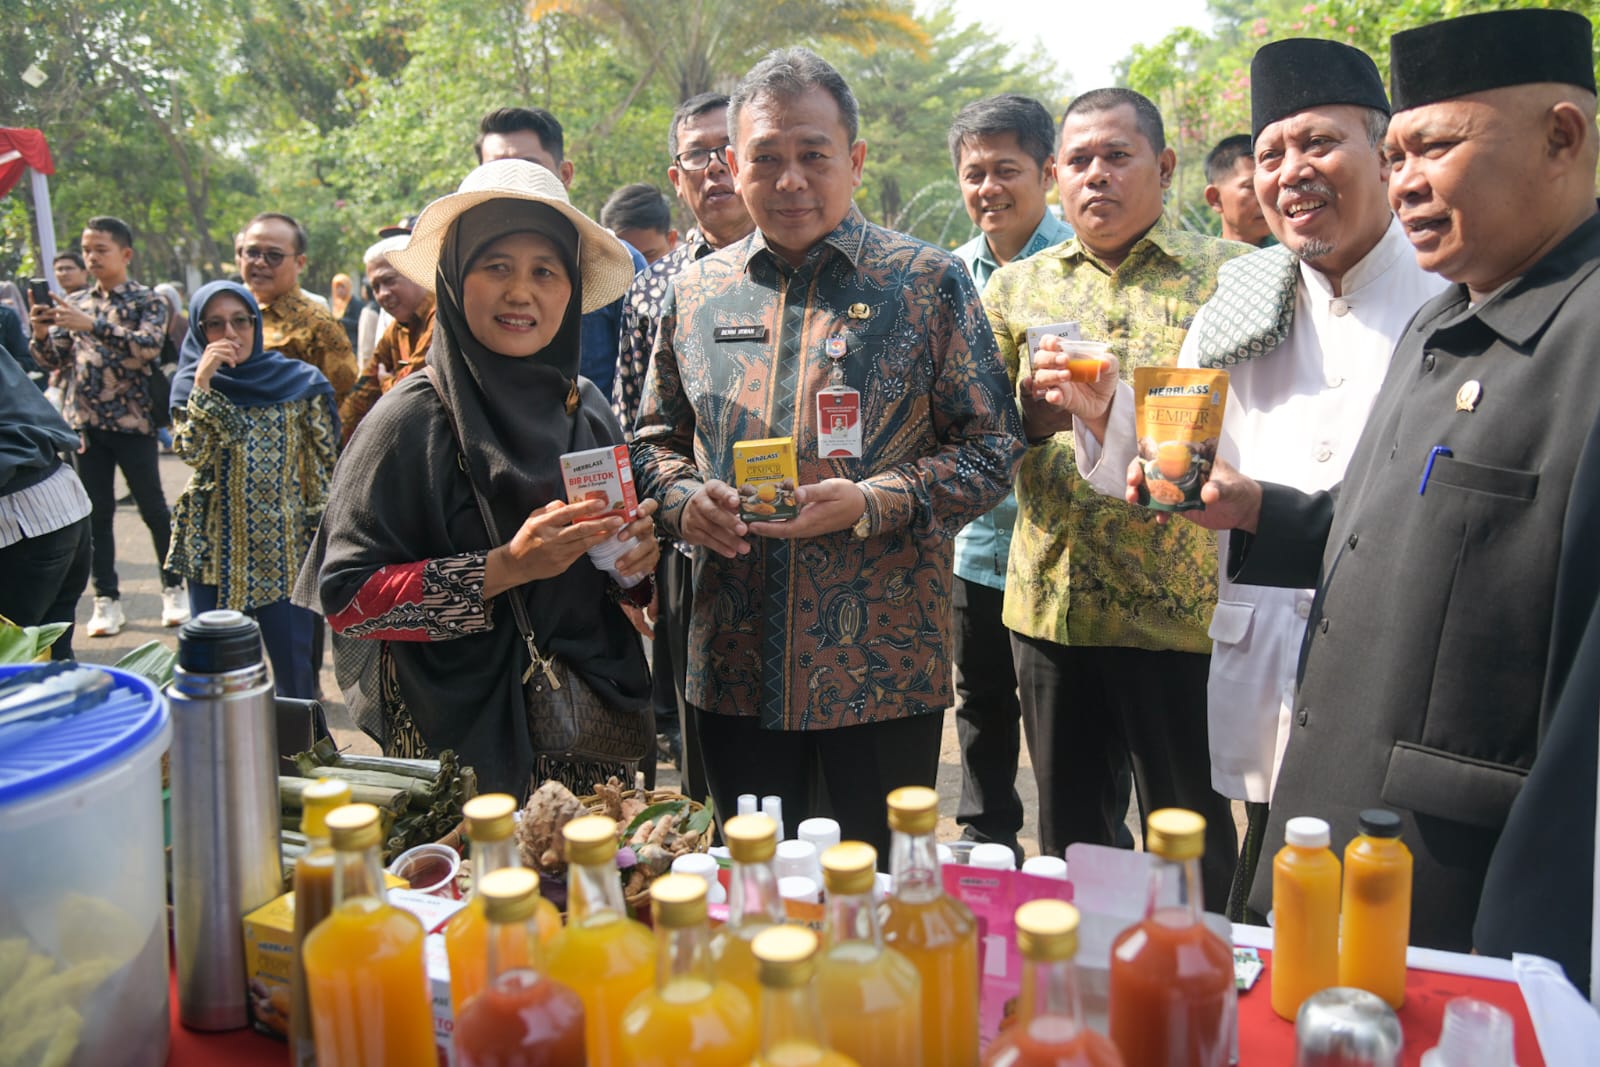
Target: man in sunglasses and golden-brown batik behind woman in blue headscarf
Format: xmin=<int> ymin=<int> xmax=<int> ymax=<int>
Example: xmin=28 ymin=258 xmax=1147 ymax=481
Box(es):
xmin=237 ymin=211 xmax=357 ymax=402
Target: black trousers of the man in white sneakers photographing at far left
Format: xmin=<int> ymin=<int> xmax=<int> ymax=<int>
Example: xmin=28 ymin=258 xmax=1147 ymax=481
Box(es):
xmin=78 ymin=430 xmax=173 ymax=600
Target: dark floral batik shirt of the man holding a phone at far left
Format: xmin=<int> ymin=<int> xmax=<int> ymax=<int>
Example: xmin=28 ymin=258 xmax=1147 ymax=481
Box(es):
xmin=29 ymin=282 xmax=168 ymax=437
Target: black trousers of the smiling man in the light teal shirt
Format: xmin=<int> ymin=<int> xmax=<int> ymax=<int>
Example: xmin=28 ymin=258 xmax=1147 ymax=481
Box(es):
xmin=950 ymin=576 xmax=1022 ymax=849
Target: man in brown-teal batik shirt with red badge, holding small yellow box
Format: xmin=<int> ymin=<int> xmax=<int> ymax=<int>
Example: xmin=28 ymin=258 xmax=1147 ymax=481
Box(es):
xmin=634 ymin=48 xmax=1022 ymax=856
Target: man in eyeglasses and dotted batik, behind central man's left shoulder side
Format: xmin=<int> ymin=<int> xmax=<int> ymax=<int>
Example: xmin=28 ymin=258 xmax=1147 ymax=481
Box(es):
xmin=611 ymin=93 xmax=755 ymax=797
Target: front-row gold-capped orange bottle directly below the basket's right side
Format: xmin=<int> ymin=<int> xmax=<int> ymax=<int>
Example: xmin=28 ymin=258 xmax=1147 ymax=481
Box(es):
xmin=622 ymin=875 xmax=757 ymax=1067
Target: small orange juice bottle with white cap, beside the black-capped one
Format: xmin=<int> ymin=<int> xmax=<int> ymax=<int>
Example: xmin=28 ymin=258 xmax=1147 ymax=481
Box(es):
xmin=1272 ymin=816 xmax=1339 ymax=1022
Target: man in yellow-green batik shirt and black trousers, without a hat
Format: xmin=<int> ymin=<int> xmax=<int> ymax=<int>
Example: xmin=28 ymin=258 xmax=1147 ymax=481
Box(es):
xmin=984 ymin=90 xmax=1250 ymax=909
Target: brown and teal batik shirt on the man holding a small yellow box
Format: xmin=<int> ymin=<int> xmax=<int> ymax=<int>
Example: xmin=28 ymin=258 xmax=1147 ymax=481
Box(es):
xmin=634 ymin=211 xmax=1022 ymax=729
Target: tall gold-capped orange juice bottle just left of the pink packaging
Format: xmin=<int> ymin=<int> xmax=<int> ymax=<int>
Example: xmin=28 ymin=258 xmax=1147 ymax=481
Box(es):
xmin=883 ymin=785 xmax=978 ymax=1067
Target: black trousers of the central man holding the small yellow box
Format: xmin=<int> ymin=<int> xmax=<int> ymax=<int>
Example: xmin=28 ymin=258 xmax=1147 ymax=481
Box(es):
xmin=693 ymin=707 xmax=944 ymax=870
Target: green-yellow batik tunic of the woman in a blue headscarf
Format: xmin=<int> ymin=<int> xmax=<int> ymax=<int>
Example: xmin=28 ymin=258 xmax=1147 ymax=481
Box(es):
xmin=166 ymin=389 xmax=338 ymax=611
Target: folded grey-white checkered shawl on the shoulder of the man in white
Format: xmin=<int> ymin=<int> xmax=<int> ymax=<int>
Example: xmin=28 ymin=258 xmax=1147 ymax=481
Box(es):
xmin=1195 ymin=245 xmax=1301 ymax=370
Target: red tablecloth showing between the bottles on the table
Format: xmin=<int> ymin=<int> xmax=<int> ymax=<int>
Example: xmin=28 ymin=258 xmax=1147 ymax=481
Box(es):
xmin=166 ymin=950 xmax=1544 ymax=1067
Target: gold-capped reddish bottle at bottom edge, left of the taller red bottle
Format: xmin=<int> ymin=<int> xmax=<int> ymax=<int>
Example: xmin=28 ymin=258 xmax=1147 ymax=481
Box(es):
xmin=984 ymin=901 xmax=1123 ymax=1067
